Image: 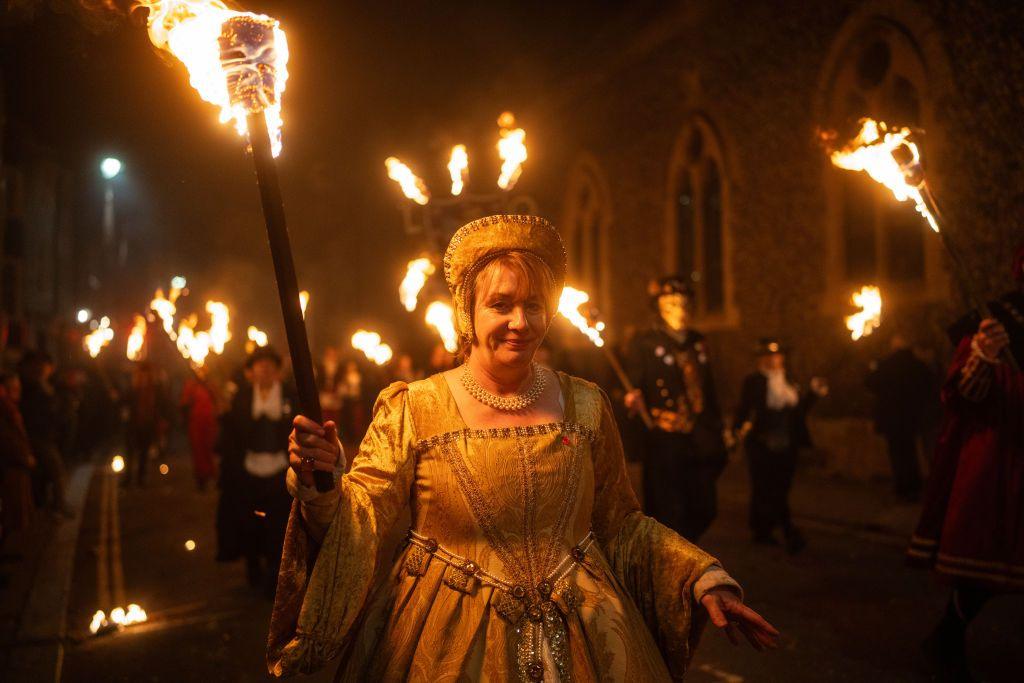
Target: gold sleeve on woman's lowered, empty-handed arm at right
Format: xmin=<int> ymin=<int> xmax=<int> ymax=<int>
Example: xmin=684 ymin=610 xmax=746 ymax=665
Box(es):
xmin=593 ymin=393 xmax=717 ymax=680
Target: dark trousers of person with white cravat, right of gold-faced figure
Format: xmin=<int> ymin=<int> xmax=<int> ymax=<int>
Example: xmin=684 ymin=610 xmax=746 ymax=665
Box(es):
xmin=743 ymin=439 xmax=797 ymax=539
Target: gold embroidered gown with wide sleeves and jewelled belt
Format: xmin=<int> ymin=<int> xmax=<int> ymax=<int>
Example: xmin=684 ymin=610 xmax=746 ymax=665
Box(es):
xmin=267 ymin=373 xmax=715 ymax=682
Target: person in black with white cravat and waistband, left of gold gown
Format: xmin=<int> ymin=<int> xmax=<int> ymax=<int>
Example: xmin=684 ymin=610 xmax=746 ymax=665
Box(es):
xmin=218 ymin=346 xmax=298 ymax=597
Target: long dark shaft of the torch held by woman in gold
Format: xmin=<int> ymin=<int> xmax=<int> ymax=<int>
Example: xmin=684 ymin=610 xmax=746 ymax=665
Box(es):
xmin=247 ymin=112 xmax=334 ymax=492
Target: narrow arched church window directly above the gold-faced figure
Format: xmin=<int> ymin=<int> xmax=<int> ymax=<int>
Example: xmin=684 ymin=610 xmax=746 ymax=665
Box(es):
xmin=667 ymin=117 xmax=734 ymax=324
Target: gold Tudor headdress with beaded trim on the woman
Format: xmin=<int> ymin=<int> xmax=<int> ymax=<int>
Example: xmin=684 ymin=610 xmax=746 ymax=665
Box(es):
xmin=444 ymin=215 xmax=566 ymax=337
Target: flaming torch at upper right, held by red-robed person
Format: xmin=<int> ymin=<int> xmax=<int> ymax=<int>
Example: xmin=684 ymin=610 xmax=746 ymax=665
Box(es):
xmin=825 ymin=119 xmax=1019 ymax=370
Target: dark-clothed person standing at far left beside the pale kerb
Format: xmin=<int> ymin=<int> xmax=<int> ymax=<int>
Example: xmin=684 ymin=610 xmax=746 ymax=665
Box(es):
xmin=18 ymin=351 xmax=73 ymax=517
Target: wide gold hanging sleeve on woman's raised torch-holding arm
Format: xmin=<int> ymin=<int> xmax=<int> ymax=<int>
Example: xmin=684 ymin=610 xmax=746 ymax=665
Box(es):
xmin=267 ymin=382 xmax=415 ymax=676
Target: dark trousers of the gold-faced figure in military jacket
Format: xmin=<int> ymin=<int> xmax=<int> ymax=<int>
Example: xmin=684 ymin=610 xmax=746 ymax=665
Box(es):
xmin=643 ymin=431 xmax=722 ymax=543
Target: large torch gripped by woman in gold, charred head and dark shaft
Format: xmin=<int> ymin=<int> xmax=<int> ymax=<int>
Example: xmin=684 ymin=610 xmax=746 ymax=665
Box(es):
xmin=218 ymin=14 xmax=334 ymax=492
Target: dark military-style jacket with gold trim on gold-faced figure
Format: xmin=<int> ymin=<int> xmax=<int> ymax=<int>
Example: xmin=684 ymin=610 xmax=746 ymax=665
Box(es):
xmin=627 ymin=325 xmax=724 ymax=452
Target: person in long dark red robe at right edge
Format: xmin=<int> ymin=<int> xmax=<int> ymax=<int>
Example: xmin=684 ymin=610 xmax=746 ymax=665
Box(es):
xmin=907 ymin=245 xmax=1024 ymax=681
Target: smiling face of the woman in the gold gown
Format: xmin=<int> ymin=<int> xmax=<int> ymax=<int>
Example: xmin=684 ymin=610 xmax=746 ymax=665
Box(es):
xmin=473 ymin=264 xmax=548 ymax=367
